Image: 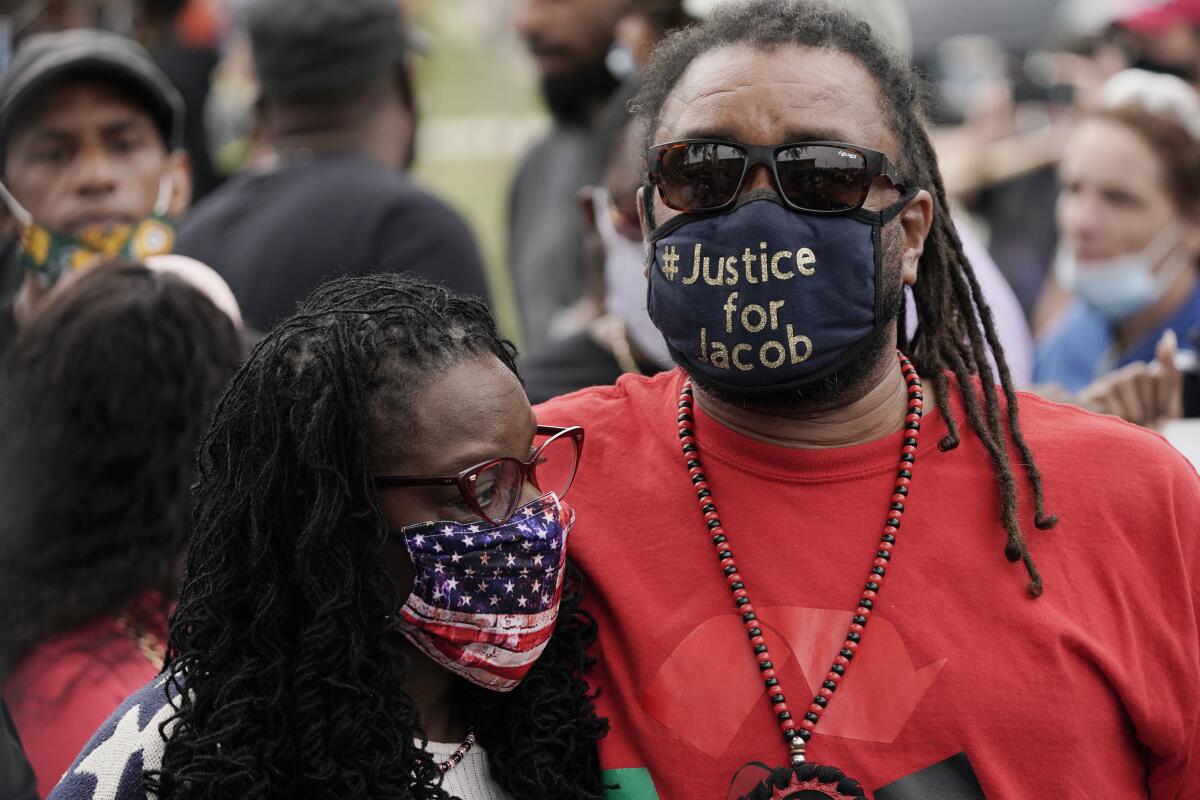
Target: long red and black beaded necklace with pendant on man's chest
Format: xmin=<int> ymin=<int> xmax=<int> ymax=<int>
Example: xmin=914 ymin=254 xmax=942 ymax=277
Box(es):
xmin=678 ymin=351 xmax=925 ymax=800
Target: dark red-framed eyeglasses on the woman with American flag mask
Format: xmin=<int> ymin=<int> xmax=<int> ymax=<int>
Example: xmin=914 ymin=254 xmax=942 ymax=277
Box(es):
xmin=374 ymin=425 xmax=583 ymax=525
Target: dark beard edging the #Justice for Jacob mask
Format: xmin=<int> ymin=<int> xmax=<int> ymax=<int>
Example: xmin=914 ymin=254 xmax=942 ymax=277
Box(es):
xmin=672 ymin=223 xmax=905 ymax=416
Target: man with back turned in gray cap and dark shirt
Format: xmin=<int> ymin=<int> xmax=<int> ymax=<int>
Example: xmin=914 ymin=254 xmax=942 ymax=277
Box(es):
xmin=178 ymin=0 xmax=486 ymax=330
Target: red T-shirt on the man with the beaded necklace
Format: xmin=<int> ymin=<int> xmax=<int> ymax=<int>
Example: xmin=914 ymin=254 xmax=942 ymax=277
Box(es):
xmin=536 ymin=371 xmax=1200 ymax=800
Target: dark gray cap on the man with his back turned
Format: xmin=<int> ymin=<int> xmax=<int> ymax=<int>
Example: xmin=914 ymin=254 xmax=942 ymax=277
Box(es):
xmin=245 ymin=0 xmax=414 ymax=103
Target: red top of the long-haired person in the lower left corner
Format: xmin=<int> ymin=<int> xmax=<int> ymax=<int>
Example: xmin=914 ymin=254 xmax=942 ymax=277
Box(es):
xmin=4 ymin=593 xmax=167 ymax=798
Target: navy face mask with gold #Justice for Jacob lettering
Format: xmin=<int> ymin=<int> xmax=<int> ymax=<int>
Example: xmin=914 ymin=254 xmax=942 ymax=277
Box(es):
xmin=644 ymin=190 xmax=917 ymax=395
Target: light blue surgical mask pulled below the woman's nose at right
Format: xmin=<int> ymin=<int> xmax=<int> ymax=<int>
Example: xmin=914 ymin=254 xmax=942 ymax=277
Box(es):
xmin=1054 ymin=223 xmax=1189 ymax=323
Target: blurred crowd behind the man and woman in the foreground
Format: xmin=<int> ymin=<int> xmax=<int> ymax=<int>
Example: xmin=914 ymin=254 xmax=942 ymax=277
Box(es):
xmin=0 ymin=0 xmax=1200 ymax=794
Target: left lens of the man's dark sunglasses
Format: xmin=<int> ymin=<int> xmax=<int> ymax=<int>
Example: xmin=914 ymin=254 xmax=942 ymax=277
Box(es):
xmin=659 ymin=143 xmax=746 ymax=211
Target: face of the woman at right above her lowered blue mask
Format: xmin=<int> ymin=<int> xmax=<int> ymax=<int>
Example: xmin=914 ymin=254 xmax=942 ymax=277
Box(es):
xmin=1057 ymin=119 xmax=1200 ymax=261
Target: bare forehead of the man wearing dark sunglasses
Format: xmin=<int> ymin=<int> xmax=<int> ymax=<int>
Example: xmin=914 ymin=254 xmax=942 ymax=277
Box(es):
xmin=655 ymin=44 xmax=896 ymax=157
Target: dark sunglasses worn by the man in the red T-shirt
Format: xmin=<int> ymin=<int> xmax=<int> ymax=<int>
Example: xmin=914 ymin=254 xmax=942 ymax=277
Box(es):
xmin=649 ymin=139 xmax=905 ymax=213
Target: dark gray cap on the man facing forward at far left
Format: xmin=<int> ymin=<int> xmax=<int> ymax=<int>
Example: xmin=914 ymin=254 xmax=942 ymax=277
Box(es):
xmin=0 ymin=29 xmax=184 ymax=164
